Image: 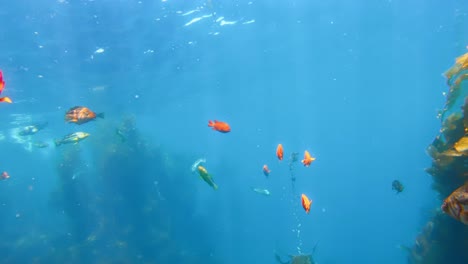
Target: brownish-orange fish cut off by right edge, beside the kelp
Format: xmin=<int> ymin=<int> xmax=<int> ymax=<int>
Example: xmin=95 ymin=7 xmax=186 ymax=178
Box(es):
xmin=441 ymin=183 xmax=468 ymax=225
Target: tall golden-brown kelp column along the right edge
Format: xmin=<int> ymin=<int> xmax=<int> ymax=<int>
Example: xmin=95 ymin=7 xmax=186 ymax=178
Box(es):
xmin=408 ymin=53 xmax=468 ymax=264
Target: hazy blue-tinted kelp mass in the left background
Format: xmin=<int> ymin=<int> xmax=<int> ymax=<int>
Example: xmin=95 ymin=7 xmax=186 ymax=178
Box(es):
xmin=0 ymin=117 xmax=221 ymax=264
